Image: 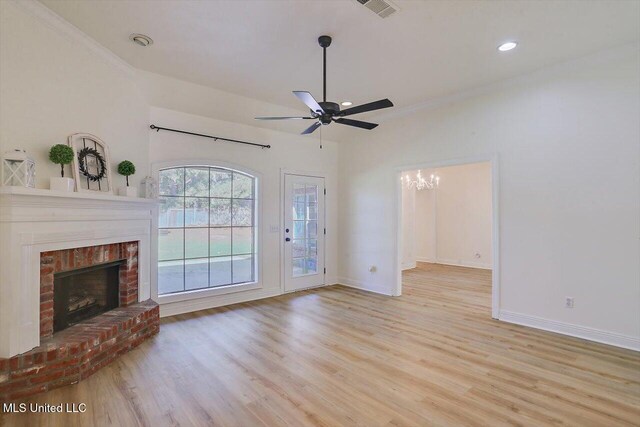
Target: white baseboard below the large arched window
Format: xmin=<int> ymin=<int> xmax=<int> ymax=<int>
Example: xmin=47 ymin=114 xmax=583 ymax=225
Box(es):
xmin=160 ymin=288 xmax=282 ymax=317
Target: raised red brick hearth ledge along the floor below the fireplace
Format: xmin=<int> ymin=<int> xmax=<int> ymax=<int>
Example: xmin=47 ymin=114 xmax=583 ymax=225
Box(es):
xmin=0 ymin=300 xmax=160 ymax=403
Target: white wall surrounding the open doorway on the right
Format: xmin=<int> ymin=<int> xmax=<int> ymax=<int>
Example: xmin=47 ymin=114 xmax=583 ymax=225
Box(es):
xmin=339 ymin=44 xmax=640 ymax=348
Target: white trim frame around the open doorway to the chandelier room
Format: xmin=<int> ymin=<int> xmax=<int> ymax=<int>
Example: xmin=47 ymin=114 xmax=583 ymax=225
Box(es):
xmin=393 ymin=153 xmax=500 ymax=319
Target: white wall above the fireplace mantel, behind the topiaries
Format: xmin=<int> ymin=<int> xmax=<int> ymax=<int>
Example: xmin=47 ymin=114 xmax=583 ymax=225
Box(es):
xmin=0 ymin=1 xmax=149 ymax=188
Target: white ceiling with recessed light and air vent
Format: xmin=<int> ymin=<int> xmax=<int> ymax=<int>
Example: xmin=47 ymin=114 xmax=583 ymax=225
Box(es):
xmin=41 ymin=0 xmax=640 ymax=132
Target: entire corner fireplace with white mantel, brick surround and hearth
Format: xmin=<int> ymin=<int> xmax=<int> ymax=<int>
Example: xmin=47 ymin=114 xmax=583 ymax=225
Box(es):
xmin=0 ymin=187 xmax=160 ymax=403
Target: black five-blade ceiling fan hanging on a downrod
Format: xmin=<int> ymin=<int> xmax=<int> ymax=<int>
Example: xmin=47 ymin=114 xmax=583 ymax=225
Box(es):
xmin=256 ymin=36 xmax=393 ymax=135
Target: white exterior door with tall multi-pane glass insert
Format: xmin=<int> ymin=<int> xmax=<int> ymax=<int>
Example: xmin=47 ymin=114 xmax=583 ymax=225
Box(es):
xmin=283 ymin=174 xmax=325 ymax=292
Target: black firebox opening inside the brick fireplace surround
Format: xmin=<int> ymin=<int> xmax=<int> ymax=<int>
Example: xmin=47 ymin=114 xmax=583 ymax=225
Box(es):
xmin=53 ymin=260 xmax=125 ymax=332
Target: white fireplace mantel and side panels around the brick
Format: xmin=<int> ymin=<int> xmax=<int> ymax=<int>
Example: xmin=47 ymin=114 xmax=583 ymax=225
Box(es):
xmin=0 ymin=187 xmax=157 ymax=357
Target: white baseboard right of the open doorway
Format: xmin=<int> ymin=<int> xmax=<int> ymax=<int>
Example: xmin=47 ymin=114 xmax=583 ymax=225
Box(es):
xmin=498 ymin=310 xmax=640 ymax=351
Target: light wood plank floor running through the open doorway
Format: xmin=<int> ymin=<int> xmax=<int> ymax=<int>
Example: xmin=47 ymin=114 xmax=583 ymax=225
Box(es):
xmin=0 ymin=264 xmax=640 ymax=427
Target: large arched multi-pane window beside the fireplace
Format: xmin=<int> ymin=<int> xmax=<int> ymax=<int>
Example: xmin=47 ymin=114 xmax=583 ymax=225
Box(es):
xmin=158 ymin=166 xmax=256 ymax=295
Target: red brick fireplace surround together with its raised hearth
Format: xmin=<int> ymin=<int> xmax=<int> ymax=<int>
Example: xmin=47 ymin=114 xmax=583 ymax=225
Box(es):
xmin=0 ymin=241 xmax=160 ymax=402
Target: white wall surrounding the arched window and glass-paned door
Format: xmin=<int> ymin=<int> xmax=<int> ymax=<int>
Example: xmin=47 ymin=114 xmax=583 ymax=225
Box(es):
xmin=150 ymin=100 xmax=338 ymax=316
